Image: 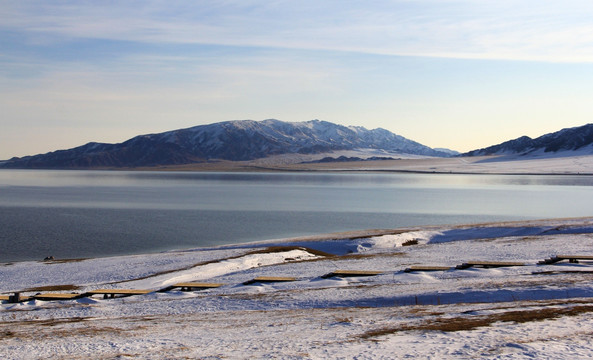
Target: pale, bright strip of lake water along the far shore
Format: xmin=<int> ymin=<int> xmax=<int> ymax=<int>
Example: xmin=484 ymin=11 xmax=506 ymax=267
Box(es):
xmin=0 ymin=169 xmax=593 ymax=187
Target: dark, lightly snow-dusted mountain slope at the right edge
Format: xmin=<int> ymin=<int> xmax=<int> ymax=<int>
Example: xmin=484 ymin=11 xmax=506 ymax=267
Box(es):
xmin=463 ymin=124 xmax=593 ymax=156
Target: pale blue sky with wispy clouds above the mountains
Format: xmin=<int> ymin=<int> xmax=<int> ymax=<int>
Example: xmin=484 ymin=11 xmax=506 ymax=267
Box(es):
xmin=0 ymin=0 xmax=593 ymax=159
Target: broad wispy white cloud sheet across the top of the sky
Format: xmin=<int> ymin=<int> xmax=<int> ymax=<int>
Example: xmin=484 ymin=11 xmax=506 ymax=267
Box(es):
xmin=0 ymin=0 xmax=593 ymax=62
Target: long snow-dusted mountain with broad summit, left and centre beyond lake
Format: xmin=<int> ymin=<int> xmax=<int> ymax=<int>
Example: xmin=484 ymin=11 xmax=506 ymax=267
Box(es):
xmin=0 ymin=119 xmax=451 ymax=168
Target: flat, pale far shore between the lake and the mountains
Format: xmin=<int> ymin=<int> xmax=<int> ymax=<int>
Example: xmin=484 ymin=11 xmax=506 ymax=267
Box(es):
xmin=0 ymin=154 xmax=593 ymax=176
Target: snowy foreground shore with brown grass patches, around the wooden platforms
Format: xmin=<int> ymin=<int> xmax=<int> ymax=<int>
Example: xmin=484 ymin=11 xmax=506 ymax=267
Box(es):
xmin=0 ymin=218 xmax=593 ymax=359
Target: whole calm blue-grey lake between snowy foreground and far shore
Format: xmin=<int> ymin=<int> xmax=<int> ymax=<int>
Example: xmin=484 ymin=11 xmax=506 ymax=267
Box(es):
xmin=0 ymin=170 xmax=593 ymax=262
